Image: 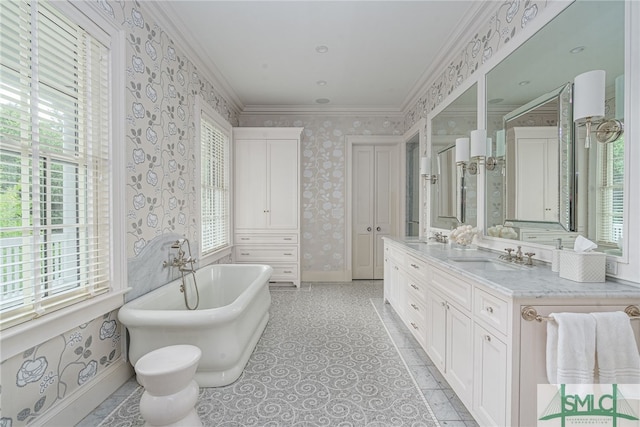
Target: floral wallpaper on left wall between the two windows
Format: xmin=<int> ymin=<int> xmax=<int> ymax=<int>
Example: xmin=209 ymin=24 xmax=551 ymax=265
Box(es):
xmin=99 ymin=1 xmax=238 ymax=257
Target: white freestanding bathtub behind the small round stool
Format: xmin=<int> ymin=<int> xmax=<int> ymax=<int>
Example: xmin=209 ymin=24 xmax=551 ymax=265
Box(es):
xmin=118 ymin=264 xmax=273 ymax=387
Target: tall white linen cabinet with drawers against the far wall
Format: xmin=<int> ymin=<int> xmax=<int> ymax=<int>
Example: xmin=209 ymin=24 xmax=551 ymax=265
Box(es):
xmin=233 ymin=127 xmax=303 ymax=287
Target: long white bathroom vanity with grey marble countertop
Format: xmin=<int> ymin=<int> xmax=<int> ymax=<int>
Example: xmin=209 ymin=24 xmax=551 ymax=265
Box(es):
xmin=384 ymin=238 xmax=640 ymax=426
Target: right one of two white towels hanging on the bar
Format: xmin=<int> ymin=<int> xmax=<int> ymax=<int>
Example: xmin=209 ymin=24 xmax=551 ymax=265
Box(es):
xmin=591 ymin=311 xmax=640 ymax=384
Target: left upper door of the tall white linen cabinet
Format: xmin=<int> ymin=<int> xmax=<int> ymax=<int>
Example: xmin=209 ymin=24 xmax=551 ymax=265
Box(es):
xmin=234 ymin=139 xmax=267 ymax=229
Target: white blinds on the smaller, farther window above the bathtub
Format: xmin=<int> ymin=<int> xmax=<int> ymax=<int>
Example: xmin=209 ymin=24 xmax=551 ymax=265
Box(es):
xmin=200 ymin=112 xmax=230 ymax=255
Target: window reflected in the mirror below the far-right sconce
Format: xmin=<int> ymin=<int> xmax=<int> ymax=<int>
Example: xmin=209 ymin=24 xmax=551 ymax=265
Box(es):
xmin=596 ymin=137 xmax=624 ymax=245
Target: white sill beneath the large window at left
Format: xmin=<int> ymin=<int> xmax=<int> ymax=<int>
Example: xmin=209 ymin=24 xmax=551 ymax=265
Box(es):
xmin=0 ymin=289 xmax=129 ymax=362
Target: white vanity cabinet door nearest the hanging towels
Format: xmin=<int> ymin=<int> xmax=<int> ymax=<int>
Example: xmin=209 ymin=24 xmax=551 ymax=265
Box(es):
xmin=473 ymin=324 xmax=507 ymax=426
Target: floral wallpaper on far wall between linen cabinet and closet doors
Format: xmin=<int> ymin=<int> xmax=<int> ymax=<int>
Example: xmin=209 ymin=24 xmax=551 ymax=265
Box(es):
xmin=240 ymin=115 xmax=403 ymax=278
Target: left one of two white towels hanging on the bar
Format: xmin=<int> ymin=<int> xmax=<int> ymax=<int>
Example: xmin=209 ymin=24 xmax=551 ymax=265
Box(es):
xmin=547 ymin=313 xmax=596 ymax=384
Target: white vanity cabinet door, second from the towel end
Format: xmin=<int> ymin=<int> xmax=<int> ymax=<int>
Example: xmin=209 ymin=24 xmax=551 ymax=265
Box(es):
xmin=445 ymin=303 xmax=473 ymax=405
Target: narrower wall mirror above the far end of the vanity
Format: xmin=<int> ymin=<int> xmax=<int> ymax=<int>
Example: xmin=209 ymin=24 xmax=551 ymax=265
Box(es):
xmin=430 ymin=84 xmax=478 ymax=230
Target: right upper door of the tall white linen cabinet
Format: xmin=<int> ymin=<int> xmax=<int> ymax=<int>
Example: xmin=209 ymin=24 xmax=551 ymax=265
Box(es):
xmin=268 ymin=139 xmax=299 ymax=229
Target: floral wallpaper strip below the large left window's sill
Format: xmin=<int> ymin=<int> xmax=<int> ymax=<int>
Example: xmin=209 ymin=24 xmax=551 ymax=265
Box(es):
xmin=0 ymin=311 xmax=122 ymax=427
